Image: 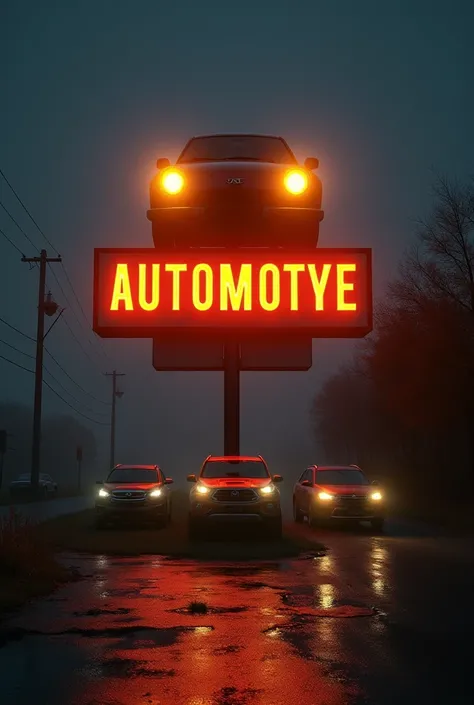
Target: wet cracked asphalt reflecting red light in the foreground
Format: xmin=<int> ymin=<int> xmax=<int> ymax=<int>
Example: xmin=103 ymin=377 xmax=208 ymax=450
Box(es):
xmin=0 ymin=523 xmax=474 ymax=705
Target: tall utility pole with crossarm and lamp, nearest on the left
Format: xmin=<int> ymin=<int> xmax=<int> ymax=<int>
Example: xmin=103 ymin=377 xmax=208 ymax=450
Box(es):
xmin=21 ymin=250 xmax=62 ymax=495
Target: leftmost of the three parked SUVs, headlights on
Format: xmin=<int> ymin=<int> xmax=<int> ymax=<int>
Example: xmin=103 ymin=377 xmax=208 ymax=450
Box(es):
xmin=95 ymin=465 xmax=173 ymax=528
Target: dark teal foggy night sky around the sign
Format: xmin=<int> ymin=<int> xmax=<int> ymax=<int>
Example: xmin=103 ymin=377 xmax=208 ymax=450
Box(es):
xmin=0 ymin=0 xmax=474 ymax=476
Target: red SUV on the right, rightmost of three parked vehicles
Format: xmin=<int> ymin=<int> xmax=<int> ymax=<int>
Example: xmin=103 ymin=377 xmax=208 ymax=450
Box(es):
xmin=293 ymin=465 xmax=385 ymax=531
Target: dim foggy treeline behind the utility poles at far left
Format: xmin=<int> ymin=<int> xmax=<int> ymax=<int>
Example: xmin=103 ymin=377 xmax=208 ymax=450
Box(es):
xmin=0 ymin=403 xmax=97 ymax=491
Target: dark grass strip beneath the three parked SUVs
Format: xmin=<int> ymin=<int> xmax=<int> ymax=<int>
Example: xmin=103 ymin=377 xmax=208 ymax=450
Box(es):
xmin=40 ymin=490 xmax=324 ymax=560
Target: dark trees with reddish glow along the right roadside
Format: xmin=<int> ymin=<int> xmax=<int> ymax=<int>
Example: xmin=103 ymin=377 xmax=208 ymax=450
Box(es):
xmin=312 ymin=179 xmax=474 ymax=508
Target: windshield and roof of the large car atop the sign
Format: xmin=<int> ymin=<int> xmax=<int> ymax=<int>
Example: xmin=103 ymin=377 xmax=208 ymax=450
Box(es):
xmin=177 ymin=135 xmax=297 ymax=164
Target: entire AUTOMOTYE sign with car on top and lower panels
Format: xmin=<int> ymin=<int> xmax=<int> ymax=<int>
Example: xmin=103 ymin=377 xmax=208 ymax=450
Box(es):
xmin=94 ymin=134 xmax=372 ymax=371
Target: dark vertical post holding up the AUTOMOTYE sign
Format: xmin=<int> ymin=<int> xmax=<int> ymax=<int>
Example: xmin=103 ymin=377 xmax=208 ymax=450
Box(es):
xmin=224 ymin=340 xmax=240 ymax=455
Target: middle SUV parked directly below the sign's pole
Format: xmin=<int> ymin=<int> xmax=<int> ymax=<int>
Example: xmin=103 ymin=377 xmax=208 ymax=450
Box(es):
xmin=187 ymin=455 xmax=282 ymax=538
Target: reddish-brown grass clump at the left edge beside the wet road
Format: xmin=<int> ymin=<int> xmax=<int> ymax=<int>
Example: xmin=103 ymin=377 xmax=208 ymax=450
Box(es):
xmin=0 ymin=510 xmax=78 ymax=612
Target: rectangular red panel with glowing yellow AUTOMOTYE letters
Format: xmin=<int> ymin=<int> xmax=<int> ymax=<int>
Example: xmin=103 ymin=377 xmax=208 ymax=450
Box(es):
xmin=93 ymin=248 xmax=372 ymax=338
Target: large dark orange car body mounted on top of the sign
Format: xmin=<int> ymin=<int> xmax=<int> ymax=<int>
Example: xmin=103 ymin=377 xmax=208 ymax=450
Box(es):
xmin=147 ymin=134 xmax=324 ymax=249
